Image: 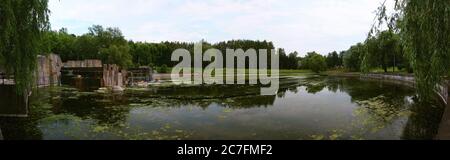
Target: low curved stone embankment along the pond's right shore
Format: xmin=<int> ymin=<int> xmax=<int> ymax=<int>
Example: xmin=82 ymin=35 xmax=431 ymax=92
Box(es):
xmin=325 ymin=72 xmax=450 ymax=140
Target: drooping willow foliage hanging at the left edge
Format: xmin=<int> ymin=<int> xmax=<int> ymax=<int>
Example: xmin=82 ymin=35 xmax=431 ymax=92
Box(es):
xmin=0 ymin=0 xmax=50 ymax=94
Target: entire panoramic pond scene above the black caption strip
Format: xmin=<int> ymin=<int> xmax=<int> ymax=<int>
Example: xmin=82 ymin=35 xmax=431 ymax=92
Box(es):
xmin=0 ymin=0 xmax=450 ymax=141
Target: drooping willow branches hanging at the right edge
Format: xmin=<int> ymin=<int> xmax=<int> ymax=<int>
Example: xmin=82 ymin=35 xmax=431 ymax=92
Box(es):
xmin=369 ymin=0 xmax=450 ymax=99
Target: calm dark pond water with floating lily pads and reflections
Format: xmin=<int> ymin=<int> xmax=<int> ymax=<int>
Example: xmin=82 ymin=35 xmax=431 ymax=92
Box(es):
xmin=0 ymin=76 xmax=443 ymax=140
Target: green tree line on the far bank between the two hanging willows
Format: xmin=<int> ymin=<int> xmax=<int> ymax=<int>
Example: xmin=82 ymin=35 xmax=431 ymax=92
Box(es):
xmin=0 ymin=12 xmax=424 ymax=76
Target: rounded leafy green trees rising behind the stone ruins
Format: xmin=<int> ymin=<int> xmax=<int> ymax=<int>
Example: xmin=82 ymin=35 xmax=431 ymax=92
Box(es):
xmin=44 ymin=25 xmax=132 ymax=68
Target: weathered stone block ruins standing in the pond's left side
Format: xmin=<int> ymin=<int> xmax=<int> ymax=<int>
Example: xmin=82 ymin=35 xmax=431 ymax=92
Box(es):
xmin=0 ymin=54 xmax=137 ymax=117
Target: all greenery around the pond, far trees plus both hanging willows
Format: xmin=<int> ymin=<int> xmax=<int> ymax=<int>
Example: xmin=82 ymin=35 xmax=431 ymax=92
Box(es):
xmin=0 ymin=0 xmax=450 ymax=100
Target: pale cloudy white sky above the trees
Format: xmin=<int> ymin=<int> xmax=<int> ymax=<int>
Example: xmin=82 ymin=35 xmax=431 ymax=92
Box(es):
xmin=49 ymin=0 xmax=382 ymax=55
